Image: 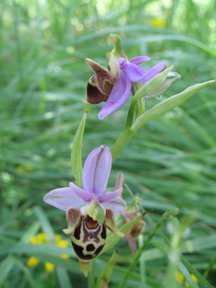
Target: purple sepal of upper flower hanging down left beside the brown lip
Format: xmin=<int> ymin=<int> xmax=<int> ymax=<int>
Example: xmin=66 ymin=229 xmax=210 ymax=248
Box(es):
xmin=98 ymin=71 xmax=131 ymax=120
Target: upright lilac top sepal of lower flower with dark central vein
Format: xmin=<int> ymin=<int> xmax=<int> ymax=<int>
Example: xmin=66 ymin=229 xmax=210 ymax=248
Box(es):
xmin=82 ymin=146 xmax=112 ymax=194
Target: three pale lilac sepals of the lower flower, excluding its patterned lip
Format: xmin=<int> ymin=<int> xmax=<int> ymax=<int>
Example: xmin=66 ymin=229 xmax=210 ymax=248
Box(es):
xmin=44 ymin=146 xmax=125 ymax=215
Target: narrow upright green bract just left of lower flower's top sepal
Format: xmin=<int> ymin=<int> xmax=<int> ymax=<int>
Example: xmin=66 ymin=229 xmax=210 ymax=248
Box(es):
xmin=71 ymin=112 xmax=87 ymax=187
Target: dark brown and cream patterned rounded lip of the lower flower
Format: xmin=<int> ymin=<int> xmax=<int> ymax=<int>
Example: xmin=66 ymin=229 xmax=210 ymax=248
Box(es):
xmin=71 ymin=216 xmax=106 ymax=262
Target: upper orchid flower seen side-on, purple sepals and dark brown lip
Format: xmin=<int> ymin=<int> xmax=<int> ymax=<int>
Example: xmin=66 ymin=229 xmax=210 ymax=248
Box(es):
xmin=86 ymin=56 xmax=166 ymax=120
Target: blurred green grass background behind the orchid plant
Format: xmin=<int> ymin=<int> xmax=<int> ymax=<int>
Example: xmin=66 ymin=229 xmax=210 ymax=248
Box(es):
xmin=0 ymin=0 xmax=216 ymax=288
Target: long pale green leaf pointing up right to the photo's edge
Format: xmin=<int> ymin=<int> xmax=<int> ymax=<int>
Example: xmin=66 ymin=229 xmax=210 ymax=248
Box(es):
xmin=131 ymin=80 xmax=216 ymax=132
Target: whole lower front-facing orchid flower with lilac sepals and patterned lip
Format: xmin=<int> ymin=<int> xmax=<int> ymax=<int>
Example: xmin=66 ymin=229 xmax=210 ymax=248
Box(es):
xmin=44 ymin=146 xmax=126 ymax=274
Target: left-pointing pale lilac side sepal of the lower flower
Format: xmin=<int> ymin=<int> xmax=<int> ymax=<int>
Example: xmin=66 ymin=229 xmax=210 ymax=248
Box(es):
xmin=43 ymin=187 xmax=85 ymax=211
